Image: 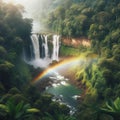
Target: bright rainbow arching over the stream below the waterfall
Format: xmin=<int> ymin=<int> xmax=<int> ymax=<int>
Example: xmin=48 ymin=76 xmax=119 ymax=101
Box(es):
xmin=32 ymin=57 xmax=82 ymax=83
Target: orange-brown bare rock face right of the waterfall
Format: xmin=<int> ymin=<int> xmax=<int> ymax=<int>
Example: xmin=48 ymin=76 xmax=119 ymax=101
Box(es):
xmin=62 ymin=38 xmax=91 ymax=47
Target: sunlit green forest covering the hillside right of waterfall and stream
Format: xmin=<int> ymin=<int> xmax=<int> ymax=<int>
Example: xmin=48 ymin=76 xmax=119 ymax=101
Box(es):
xmin=47 ymin=0 xmax=120 ymax=120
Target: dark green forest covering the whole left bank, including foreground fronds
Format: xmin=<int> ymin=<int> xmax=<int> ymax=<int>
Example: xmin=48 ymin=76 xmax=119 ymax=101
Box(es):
xmin=0 ymin=0 xmax=74 ymax=120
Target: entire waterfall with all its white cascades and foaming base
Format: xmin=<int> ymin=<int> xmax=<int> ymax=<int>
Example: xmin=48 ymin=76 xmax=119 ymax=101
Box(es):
xmin=28 ymin=34 xmax=60 ymax=68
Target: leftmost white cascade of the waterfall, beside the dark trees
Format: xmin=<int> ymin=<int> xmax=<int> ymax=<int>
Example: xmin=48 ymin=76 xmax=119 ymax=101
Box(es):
xmin=31 ymin=34 xmax=40 ymax=59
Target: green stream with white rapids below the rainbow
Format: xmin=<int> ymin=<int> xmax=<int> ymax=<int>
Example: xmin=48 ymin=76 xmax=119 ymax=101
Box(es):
xmin=45 ymin=73 xmax=81 ymax=114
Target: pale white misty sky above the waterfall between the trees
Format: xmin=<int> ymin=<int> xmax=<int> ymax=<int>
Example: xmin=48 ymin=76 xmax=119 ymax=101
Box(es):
xmin=5 ymin=0 xmax=63 ymax=33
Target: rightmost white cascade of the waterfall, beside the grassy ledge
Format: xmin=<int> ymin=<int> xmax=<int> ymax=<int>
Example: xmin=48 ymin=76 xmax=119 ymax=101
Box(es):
xmin=52 ymin=35 xmax=60 ymax=61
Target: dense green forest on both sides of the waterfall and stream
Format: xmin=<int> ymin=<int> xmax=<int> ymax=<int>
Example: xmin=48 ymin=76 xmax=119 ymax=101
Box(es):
xmin=0 ymin=0 xmax=120 ymax=120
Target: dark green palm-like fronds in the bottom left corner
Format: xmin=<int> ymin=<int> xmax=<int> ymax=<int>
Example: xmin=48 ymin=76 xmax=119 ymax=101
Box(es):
xmin=0 ymin=99 xmax=40 ymax=120
